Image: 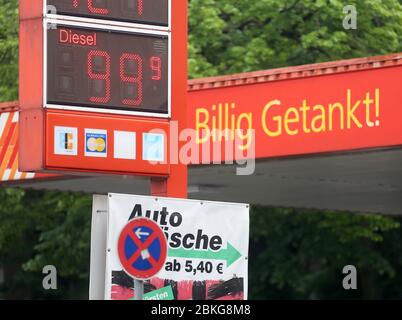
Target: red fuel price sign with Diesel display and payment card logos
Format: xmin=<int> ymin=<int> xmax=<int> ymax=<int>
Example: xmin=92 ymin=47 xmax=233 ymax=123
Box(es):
xmin=18 ymin=0 xmax=187 ymax=178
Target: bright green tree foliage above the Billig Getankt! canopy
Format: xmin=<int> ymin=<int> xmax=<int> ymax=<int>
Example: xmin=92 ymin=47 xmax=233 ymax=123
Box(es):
xmin=189 ymin=0 xmax=402 ymax=77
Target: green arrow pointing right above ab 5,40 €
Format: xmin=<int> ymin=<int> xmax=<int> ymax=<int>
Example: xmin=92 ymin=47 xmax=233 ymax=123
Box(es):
xmin=168 ymin=242 xmax=241 ymax=267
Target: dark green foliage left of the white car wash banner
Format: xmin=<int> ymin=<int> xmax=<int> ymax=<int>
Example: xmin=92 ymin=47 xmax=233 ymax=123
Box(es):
xmin=0 ymin=189 xmax=92 ymax=299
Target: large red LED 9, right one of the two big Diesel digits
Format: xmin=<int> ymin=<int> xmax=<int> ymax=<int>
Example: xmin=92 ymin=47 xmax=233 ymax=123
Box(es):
xmin=120 ymin=53 xmax=143 ymax=106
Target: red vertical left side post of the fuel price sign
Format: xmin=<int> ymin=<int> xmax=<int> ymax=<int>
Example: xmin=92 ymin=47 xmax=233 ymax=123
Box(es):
xmin=19 ymin=0 xmax=44 ymax=172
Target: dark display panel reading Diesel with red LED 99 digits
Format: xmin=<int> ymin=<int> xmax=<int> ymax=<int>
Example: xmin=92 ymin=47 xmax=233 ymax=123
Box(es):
xmin=47 ymin=25 xmax=169 ymax=114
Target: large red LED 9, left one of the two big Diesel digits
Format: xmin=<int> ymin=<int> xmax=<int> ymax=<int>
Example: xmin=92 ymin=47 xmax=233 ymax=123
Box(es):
xmin=88 ymin=50 xmax=110 ymax=103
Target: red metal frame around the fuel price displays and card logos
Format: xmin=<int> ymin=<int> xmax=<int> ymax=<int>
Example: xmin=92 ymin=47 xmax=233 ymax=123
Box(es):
xmin=19 ymin=0 xmax=187 ymax=197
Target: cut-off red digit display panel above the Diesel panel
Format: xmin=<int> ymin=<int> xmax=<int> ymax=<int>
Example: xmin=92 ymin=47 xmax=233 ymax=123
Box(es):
xmin=47 ymin=0 xmax=169 ymax=26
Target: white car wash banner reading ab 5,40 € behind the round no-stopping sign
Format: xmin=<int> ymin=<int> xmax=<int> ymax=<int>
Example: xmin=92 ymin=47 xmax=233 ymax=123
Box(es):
xmin=105 ymin=194 xmax=249 ymax=300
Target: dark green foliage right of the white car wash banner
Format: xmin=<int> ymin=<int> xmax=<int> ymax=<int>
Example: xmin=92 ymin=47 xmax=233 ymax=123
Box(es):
xmin=250 ymin=207 xmax=402 ymax=299
